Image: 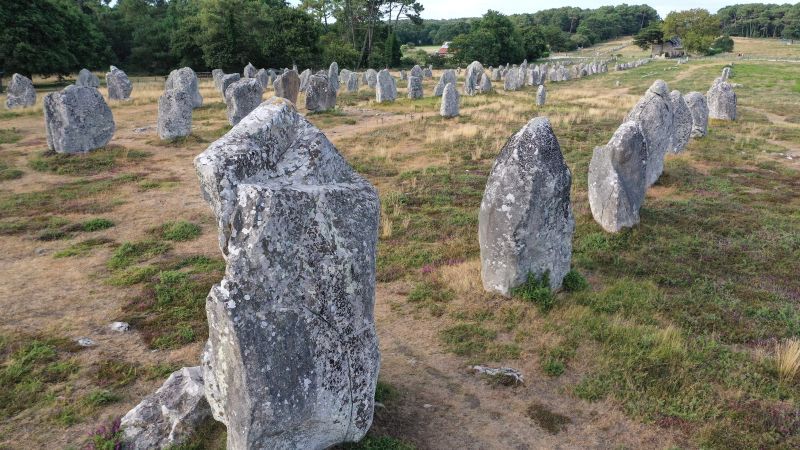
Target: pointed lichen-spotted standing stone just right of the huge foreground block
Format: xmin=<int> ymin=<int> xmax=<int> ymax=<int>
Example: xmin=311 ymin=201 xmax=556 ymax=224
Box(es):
xmin=478 ymin=117 xmax=575 ymax=296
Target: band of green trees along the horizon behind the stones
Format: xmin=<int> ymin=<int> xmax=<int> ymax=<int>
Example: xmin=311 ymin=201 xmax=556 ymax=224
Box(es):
xmin=0 ymin=0 xmax=800 ymax=75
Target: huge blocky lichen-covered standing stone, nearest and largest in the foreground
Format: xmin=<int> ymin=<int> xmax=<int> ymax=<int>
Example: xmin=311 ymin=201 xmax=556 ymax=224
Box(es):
xmin=195 ymin=98 xmax=380 ymax=450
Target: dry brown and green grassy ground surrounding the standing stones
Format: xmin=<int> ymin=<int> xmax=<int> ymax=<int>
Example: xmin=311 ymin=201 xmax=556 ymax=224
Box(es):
xmin=0 ymin=39 xmax=800 ymax=449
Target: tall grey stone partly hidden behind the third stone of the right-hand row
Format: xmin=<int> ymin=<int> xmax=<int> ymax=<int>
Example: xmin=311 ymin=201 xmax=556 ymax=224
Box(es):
xmin=625 ymin=80 xmax=675 ymax=187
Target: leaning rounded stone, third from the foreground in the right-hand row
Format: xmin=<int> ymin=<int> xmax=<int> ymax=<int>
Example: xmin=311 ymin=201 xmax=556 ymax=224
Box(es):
xmin=589 ymin=121 xmax=647 ymax=233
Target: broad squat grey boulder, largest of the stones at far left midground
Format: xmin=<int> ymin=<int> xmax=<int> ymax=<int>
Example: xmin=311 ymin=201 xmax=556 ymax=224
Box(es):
xmin=44 ymin=85 xmax=116 ymax=153
